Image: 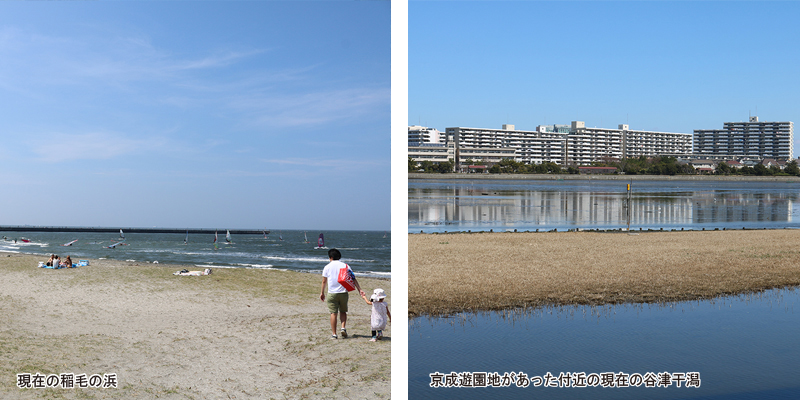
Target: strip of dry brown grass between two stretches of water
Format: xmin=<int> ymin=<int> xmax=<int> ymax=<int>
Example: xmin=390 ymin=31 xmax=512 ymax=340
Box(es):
xmin=408 ymin=230 xmax=800 ymax=316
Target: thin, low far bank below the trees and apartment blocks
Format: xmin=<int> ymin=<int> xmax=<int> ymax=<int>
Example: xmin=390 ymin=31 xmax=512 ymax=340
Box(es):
xmin=408 ymin=173 xmax=800 ymax=183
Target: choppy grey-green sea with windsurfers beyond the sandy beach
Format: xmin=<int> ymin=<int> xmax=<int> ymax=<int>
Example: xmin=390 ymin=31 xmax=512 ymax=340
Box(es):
xmin=0 ymin=230 xmax=391 ymax=278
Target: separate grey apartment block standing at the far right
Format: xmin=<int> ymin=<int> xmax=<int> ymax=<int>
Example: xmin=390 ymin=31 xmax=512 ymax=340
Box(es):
xmin=694 ymin=117 xmax=794 ymax=161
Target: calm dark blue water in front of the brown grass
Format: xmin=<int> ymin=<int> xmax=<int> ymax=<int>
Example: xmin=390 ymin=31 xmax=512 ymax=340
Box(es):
xmin=408 ymin=289 xmax=800 ymax=399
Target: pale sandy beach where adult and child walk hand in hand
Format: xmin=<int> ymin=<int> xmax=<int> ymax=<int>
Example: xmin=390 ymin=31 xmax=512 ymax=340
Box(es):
xmin=0 ymin=253 xmax=392 ymax=399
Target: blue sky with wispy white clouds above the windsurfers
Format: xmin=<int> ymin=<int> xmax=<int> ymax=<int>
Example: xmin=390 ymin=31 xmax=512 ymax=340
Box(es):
xmin=0 ymin=1 xmax=391 ymax=230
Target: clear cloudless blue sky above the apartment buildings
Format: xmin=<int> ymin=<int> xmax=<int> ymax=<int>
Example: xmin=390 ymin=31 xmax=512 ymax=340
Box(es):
xmin=408 ymin=1 xmax=800 ymax=147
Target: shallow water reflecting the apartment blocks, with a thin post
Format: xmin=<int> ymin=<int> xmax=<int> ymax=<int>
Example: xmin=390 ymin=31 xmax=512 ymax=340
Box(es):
xmin=408 ymin=180 xmax=800 ymax=233
